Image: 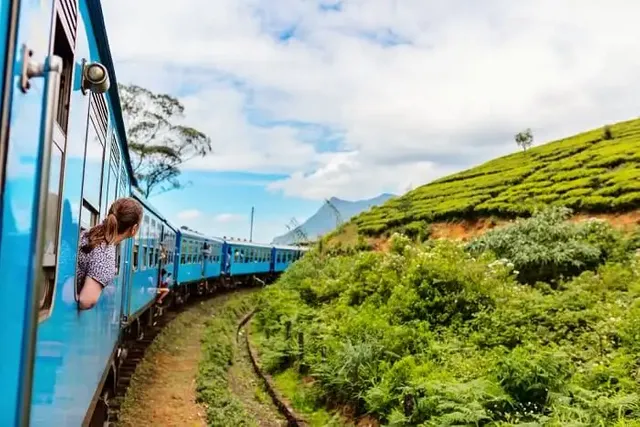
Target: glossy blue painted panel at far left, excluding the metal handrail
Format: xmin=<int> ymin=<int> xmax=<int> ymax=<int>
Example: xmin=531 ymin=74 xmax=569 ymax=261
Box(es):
xmin=0 ymin=0 xmax=57 ymax=426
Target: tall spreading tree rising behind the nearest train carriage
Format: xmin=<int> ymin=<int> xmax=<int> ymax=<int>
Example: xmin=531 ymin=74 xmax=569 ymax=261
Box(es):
xmin=118 ymin=85 xmax=211 ymax=197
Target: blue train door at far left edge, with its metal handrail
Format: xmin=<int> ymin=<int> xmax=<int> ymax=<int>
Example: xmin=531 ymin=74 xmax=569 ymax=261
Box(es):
xmin=0 ymin=0 xmax=68 ymax=426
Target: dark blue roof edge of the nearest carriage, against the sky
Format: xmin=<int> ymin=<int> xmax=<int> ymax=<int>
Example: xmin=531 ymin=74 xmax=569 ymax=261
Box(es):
xmin=86 ymin=0 xmax=138 ymax=186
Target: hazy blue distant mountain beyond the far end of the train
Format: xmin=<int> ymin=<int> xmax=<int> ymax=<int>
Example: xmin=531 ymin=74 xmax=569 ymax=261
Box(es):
xmin=272 ymin=193 xmax=396 ymax=245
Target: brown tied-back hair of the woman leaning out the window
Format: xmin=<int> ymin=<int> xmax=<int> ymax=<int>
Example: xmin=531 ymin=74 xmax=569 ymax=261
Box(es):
xmin=81 ymin=197 xmax=142 ymax=254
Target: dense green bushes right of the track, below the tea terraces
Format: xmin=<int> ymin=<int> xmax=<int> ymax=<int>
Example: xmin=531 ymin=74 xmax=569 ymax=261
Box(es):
xmin=255 ymin=216 xmax=640 ymax=426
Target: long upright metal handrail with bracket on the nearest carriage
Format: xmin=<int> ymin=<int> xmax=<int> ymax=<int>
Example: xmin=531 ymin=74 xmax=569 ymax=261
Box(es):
xmin=20 ymin=45 xmax=63 ymax=425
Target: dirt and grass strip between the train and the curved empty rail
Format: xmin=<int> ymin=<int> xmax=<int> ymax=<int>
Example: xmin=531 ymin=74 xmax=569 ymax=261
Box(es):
xmin=118 ymin=289 xmax=259 ymax=427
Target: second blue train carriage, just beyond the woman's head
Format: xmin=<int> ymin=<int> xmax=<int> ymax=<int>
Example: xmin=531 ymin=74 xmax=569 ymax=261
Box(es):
xmin=123 ymin=189 xmax=176 ymax=326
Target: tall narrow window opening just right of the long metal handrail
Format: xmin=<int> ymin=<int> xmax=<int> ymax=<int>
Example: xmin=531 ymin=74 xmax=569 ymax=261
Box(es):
xmin=38 ymin=0 xmax=78 ymax=320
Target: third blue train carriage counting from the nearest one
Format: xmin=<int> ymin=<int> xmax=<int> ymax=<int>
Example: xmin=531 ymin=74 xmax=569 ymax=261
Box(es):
xmin=174 ymin=227 xmax=223 ymax=303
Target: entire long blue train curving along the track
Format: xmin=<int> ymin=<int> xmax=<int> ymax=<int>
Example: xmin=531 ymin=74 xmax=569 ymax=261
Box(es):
xmin=0 ymin=0 xmax=304 ymax=427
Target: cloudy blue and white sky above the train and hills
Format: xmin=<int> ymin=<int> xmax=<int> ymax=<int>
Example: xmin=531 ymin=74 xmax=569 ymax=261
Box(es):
xmin=103 ymin=0 xmax=640 ymax=242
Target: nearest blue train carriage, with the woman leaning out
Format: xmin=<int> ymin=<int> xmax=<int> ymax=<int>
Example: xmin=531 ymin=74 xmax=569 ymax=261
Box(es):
xmin=0 ymin=0 xmax=132 ymax=426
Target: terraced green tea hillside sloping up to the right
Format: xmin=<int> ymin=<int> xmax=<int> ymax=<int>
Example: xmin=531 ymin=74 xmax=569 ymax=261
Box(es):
xmin=352 ymin=119 xmax=640 ymax=236
